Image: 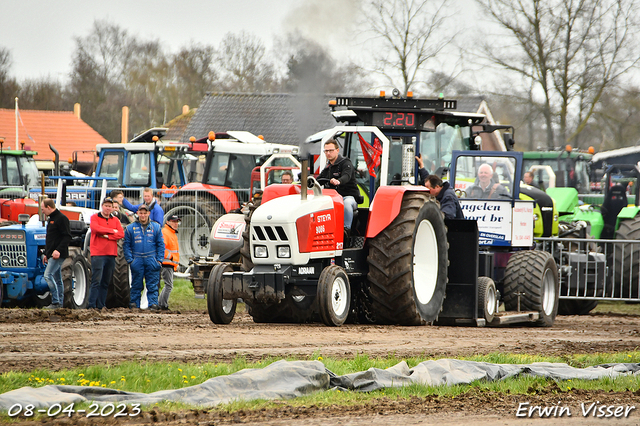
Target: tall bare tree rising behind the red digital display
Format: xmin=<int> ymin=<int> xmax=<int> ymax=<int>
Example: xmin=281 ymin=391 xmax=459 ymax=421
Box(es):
xmin=364 ymin=0 xmax=457 ymax=93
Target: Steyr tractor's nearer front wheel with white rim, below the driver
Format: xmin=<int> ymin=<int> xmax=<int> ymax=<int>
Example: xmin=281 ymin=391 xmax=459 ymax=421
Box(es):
xmin=316 ymin=265 xmax=351 ymax=327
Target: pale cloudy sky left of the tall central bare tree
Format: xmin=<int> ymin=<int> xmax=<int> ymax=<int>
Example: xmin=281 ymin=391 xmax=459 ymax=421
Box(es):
xmin=0 ymin=0 xmax=370 ymax=81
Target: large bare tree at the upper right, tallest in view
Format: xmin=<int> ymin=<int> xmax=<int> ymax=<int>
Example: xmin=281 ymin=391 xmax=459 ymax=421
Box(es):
xmin=477 ymin=0 xmax=639 ymax=148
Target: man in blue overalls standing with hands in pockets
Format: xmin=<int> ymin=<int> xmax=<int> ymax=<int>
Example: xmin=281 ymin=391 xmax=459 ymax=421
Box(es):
xmin=123 ymin=204 xmax=164 ymax=311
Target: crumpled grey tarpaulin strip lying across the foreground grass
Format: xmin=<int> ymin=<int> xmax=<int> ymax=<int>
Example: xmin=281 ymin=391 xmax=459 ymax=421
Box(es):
xmin=0 ymin=359 xmax=640 ymax=410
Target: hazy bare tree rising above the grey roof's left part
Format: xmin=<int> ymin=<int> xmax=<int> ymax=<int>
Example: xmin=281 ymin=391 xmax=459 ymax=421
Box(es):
xmin=219 ymin=31 xmax=276 ymax=92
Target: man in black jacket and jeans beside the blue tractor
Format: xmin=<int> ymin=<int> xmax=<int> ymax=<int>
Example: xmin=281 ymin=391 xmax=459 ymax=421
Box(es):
xmin=41 ymin=198 xmax=71 ymax=309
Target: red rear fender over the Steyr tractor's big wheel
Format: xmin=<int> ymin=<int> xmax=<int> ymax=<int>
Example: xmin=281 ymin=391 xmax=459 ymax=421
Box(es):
xmin=366 ymin=185 xmax=429 ymax=238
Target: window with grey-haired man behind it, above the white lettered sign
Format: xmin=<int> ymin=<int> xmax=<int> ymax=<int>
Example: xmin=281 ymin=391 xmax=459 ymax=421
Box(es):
xmin=454 ymin=156 xmax=516 ymax=199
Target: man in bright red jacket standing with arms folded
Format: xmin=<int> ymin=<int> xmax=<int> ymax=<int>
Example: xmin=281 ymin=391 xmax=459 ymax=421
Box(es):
xmin=87 ymin=197 xmax=124 ymax=309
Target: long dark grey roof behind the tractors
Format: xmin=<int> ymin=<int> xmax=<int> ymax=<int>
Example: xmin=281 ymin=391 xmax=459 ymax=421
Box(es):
xmin=181 ymin=93 xmax=336 ymax=145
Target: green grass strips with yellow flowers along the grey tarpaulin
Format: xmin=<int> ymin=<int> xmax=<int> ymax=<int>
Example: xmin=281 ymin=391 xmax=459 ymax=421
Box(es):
xmin=0 ymin=351 xmax=640 ymax=418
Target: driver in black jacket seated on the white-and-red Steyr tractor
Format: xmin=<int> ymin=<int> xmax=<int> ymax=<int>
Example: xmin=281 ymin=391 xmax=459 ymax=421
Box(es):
xmin=318 ymin=139 xmax=360 ymax=237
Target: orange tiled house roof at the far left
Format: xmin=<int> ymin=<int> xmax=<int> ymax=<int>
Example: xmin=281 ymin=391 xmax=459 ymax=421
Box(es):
xmin=0 ymin=108 xmax=109 ymax=161
